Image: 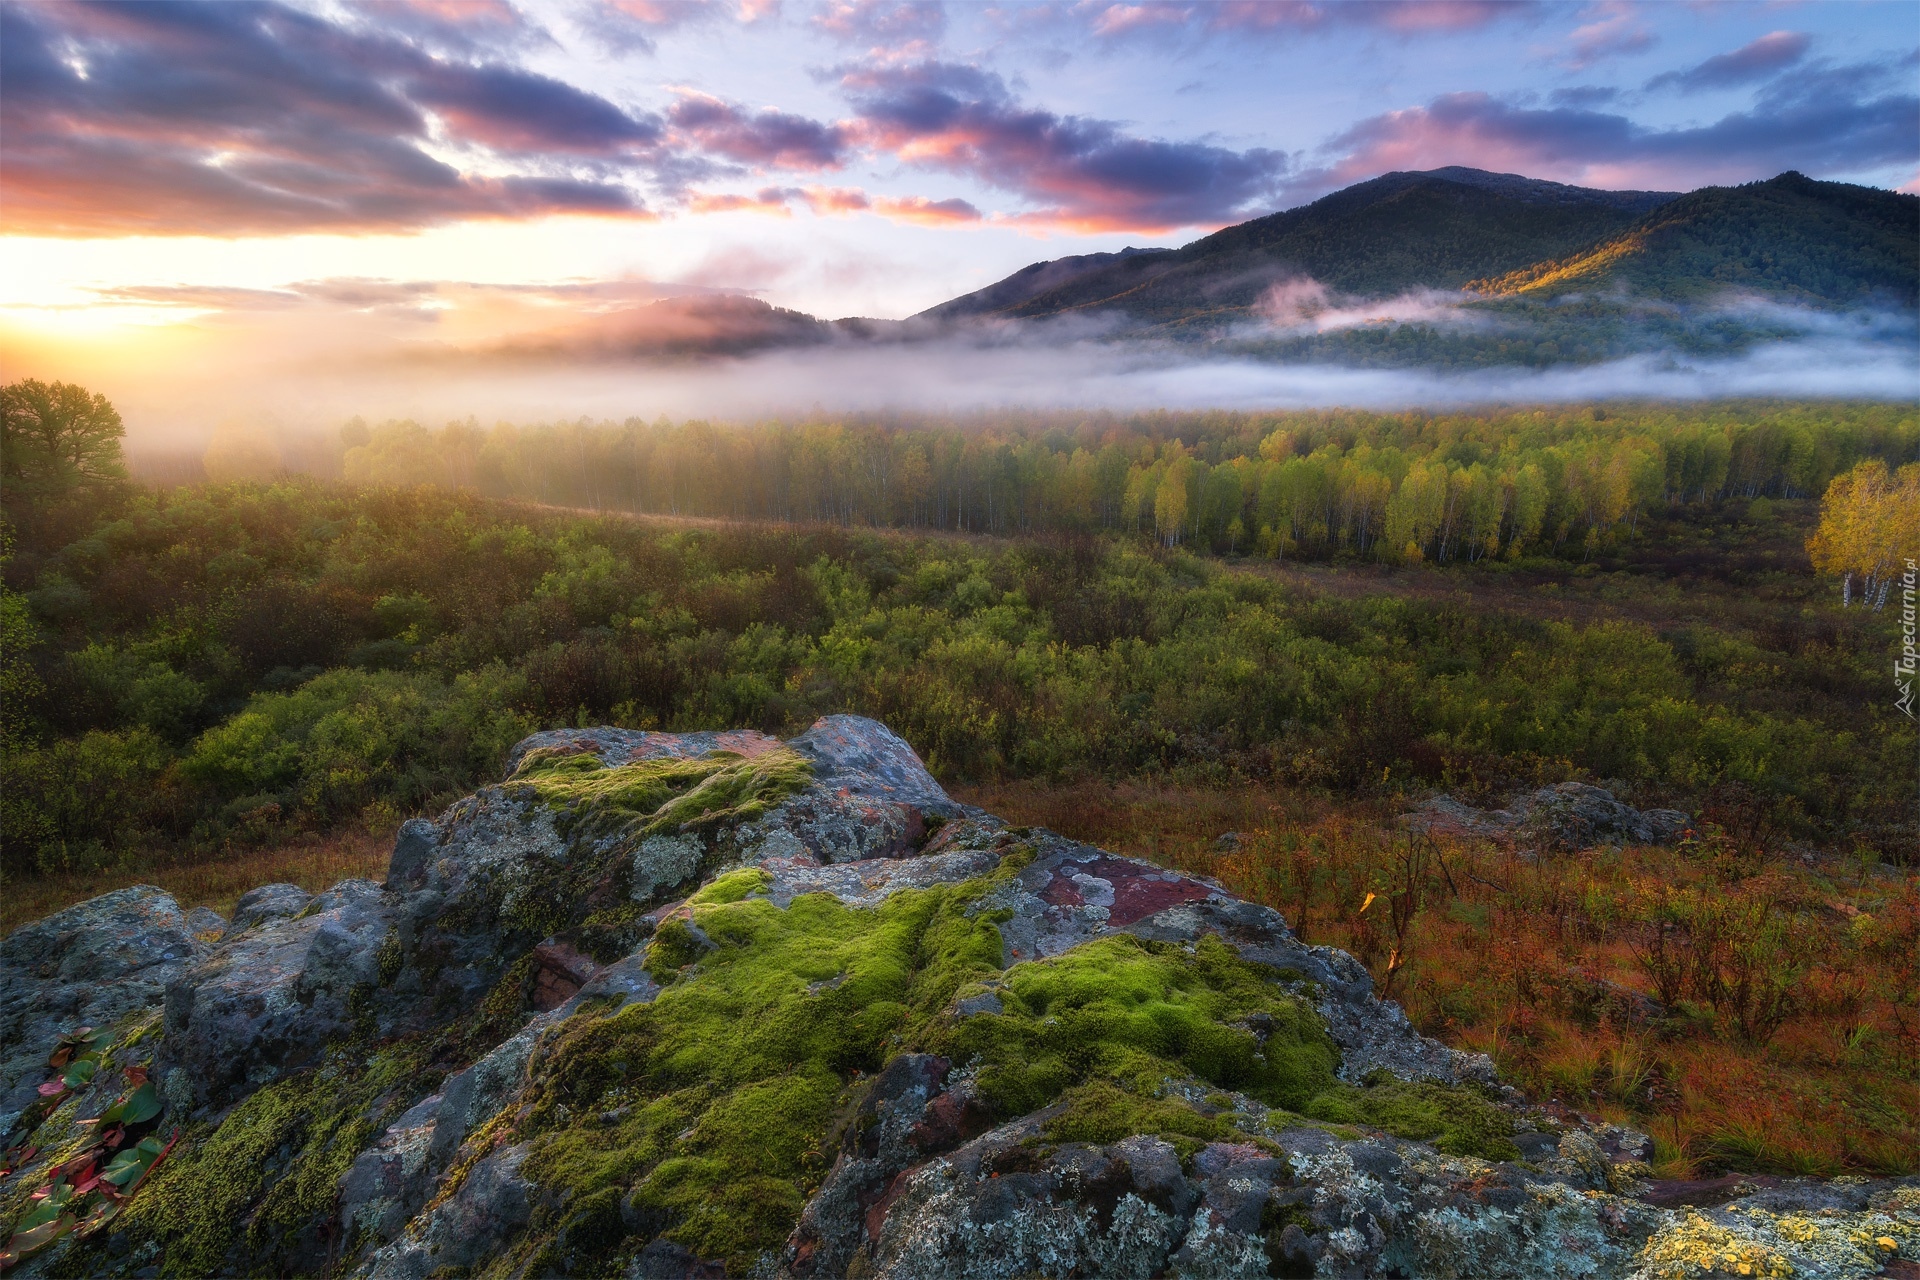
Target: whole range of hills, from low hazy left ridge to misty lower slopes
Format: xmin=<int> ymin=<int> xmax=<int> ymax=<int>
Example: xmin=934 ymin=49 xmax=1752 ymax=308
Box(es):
xmin=467 ymin=167 xmax=1920 ymax=370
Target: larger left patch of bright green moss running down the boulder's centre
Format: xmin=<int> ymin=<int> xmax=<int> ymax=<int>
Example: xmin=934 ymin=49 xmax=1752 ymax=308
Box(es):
xmin=528 ymin=864 xmax=1018 ymax=1274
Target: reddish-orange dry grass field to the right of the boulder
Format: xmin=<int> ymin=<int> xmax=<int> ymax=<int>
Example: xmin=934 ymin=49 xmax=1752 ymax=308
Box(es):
xmin=964 ymin=783 xmax=1920 ymax=1176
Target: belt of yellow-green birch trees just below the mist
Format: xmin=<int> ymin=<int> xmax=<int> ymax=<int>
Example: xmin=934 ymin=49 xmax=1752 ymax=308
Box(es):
xmin=172 ymin=401 xmax=1920 ymax=562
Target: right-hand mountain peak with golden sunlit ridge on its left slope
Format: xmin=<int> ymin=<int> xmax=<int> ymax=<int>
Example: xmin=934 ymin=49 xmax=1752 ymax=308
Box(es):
xmin=1471 ymin=173 xmax=1920 ymax=307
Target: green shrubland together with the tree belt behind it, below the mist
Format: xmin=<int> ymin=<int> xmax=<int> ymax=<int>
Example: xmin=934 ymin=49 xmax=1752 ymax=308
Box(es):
xmin=0 ymin=384 xmax=1920 ymax=875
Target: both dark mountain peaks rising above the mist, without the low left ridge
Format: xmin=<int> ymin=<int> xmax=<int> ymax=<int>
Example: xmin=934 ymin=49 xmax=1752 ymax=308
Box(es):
xmin=916 ymin=167 xmax=1920 ymax=334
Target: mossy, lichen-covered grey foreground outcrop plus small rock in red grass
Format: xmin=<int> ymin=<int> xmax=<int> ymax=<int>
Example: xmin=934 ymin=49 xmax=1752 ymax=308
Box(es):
xmin=0 ymin=716 xmax=1920 ymax=1280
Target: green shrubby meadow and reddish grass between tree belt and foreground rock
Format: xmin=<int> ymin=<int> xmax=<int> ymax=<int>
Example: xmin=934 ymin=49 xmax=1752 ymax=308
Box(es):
xmin=0 ymin=391 xmax=1920 ymax=1174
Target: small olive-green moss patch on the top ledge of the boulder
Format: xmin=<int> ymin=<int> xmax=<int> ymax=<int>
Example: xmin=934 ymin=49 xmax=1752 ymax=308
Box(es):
xmin=511 ymin=747 xmax=814 ymax=839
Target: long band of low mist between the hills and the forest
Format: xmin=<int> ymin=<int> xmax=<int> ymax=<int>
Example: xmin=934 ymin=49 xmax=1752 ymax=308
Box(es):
xmin=0 ymin=289 xmax=1920 ymax=453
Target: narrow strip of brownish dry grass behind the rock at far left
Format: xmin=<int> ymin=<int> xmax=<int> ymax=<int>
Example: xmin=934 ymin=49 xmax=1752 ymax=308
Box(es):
xmin=0 ymin=831 xmax=394 ymax=935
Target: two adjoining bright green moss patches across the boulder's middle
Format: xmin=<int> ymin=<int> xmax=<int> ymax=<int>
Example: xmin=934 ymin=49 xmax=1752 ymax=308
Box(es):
xmin=516 ymin=858 xmax=1338 ymax=1276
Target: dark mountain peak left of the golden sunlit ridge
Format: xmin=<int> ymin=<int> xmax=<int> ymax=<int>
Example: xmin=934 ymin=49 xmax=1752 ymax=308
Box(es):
xmin=922 ymin=167 xmax=1676 ymax=324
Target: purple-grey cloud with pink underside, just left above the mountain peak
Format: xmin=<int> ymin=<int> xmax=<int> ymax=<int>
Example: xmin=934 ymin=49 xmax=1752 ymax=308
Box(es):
xmin=841 ymin=61 xmax=1286 ymax=230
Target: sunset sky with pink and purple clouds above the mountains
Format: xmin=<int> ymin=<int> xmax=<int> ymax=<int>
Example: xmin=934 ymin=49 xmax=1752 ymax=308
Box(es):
xmin=0 ymin=0 xmax=1920 ymax=435
